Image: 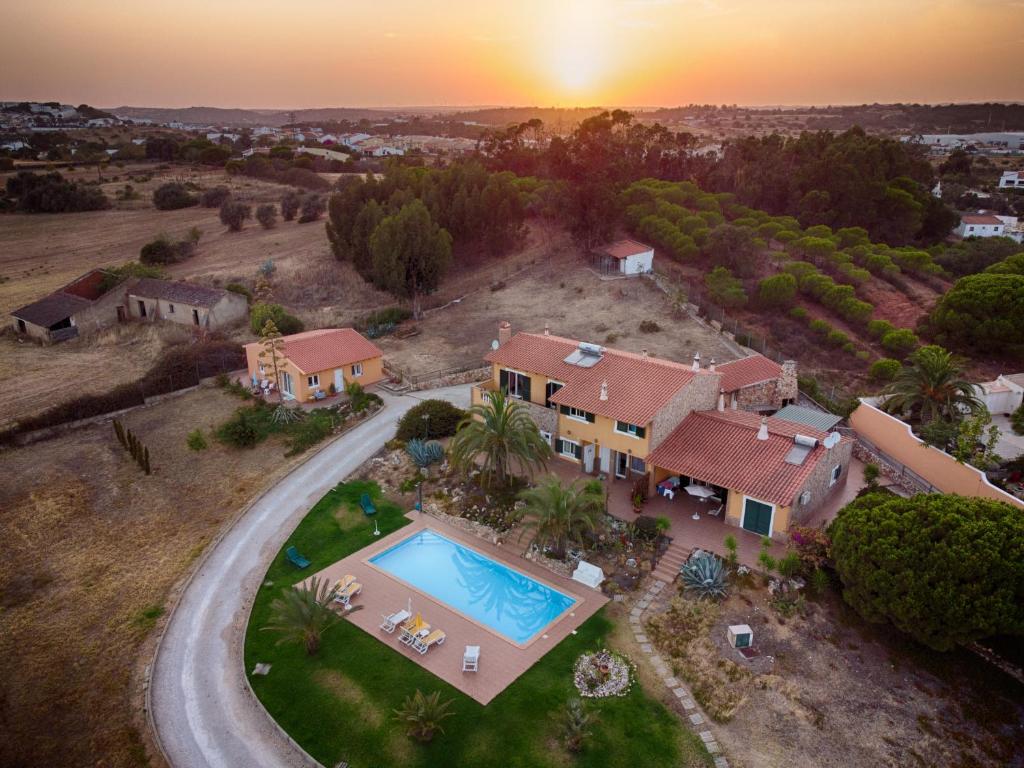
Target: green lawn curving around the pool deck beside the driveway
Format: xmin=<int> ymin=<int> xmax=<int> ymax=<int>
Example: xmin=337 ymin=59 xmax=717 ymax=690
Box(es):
xmin=246 ymin=482 xmax=711 ymax=768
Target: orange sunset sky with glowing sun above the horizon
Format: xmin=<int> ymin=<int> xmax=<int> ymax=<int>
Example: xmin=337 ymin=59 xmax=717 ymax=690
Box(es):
xmin=0 ymin=0 xmax=1024 ymax=108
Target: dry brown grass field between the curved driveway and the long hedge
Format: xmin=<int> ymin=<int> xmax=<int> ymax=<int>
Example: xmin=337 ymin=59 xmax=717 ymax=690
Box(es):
xmin=0 ymin=388 xmax=311 ymax=768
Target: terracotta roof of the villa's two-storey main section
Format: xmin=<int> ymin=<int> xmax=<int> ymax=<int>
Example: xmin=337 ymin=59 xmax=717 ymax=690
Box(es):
xmin=484 ymin=333 xmax=716 ymax=426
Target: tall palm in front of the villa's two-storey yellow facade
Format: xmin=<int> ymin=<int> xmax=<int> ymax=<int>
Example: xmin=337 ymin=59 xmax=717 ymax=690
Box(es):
xmin=449 ymin=390 xmax=551 ymax=486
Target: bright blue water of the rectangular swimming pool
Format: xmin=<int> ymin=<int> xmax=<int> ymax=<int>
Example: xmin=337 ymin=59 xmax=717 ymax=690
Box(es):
xmin=370 ymin=529 xmax=575 ymax=643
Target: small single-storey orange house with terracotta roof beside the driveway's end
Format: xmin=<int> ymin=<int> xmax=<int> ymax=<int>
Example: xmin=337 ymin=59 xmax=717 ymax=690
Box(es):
xmin=245 ymin=328 xmax=384 ymax=402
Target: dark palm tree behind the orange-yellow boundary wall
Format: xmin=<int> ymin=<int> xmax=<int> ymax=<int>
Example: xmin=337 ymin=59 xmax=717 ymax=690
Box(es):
xmin=883 ymin=344 xmax=982 ymax=425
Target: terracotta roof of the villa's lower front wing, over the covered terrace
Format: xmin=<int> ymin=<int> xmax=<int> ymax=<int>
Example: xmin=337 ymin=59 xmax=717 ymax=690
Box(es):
xmin=647 ymin=411 xmax=849 ymax=506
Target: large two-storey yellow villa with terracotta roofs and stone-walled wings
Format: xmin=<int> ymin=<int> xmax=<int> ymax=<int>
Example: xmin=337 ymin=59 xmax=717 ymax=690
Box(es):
xmin=473 ymin=323 xmax=853 ymax=537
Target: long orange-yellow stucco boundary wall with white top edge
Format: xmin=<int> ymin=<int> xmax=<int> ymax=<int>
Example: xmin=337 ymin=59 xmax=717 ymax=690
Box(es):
xmin=850 ymin=400 xmax=1024 ymax=509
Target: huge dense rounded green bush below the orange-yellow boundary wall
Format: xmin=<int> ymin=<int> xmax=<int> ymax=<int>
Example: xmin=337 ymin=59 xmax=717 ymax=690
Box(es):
xmin=828 ymin=493 xmax=1024 ymax=650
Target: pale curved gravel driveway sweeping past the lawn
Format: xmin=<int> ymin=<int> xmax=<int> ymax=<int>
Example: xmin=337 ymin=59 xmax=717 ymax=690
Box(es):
xmin=150 ymin=385 xmax=469 ymax=768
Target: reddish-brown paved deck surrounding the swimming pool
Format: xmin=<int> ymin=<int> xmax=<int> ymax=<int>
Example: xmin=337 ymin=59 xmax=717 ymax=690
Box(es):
xmin=303 ymin=512 xmax=608 ymax=705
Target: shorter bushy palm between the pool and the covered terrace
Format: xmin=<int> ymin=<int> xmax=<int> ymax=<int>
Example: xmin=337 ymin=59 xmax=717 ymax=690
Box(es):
xmin=519 ymin=477 xmax=604 ymax=559
